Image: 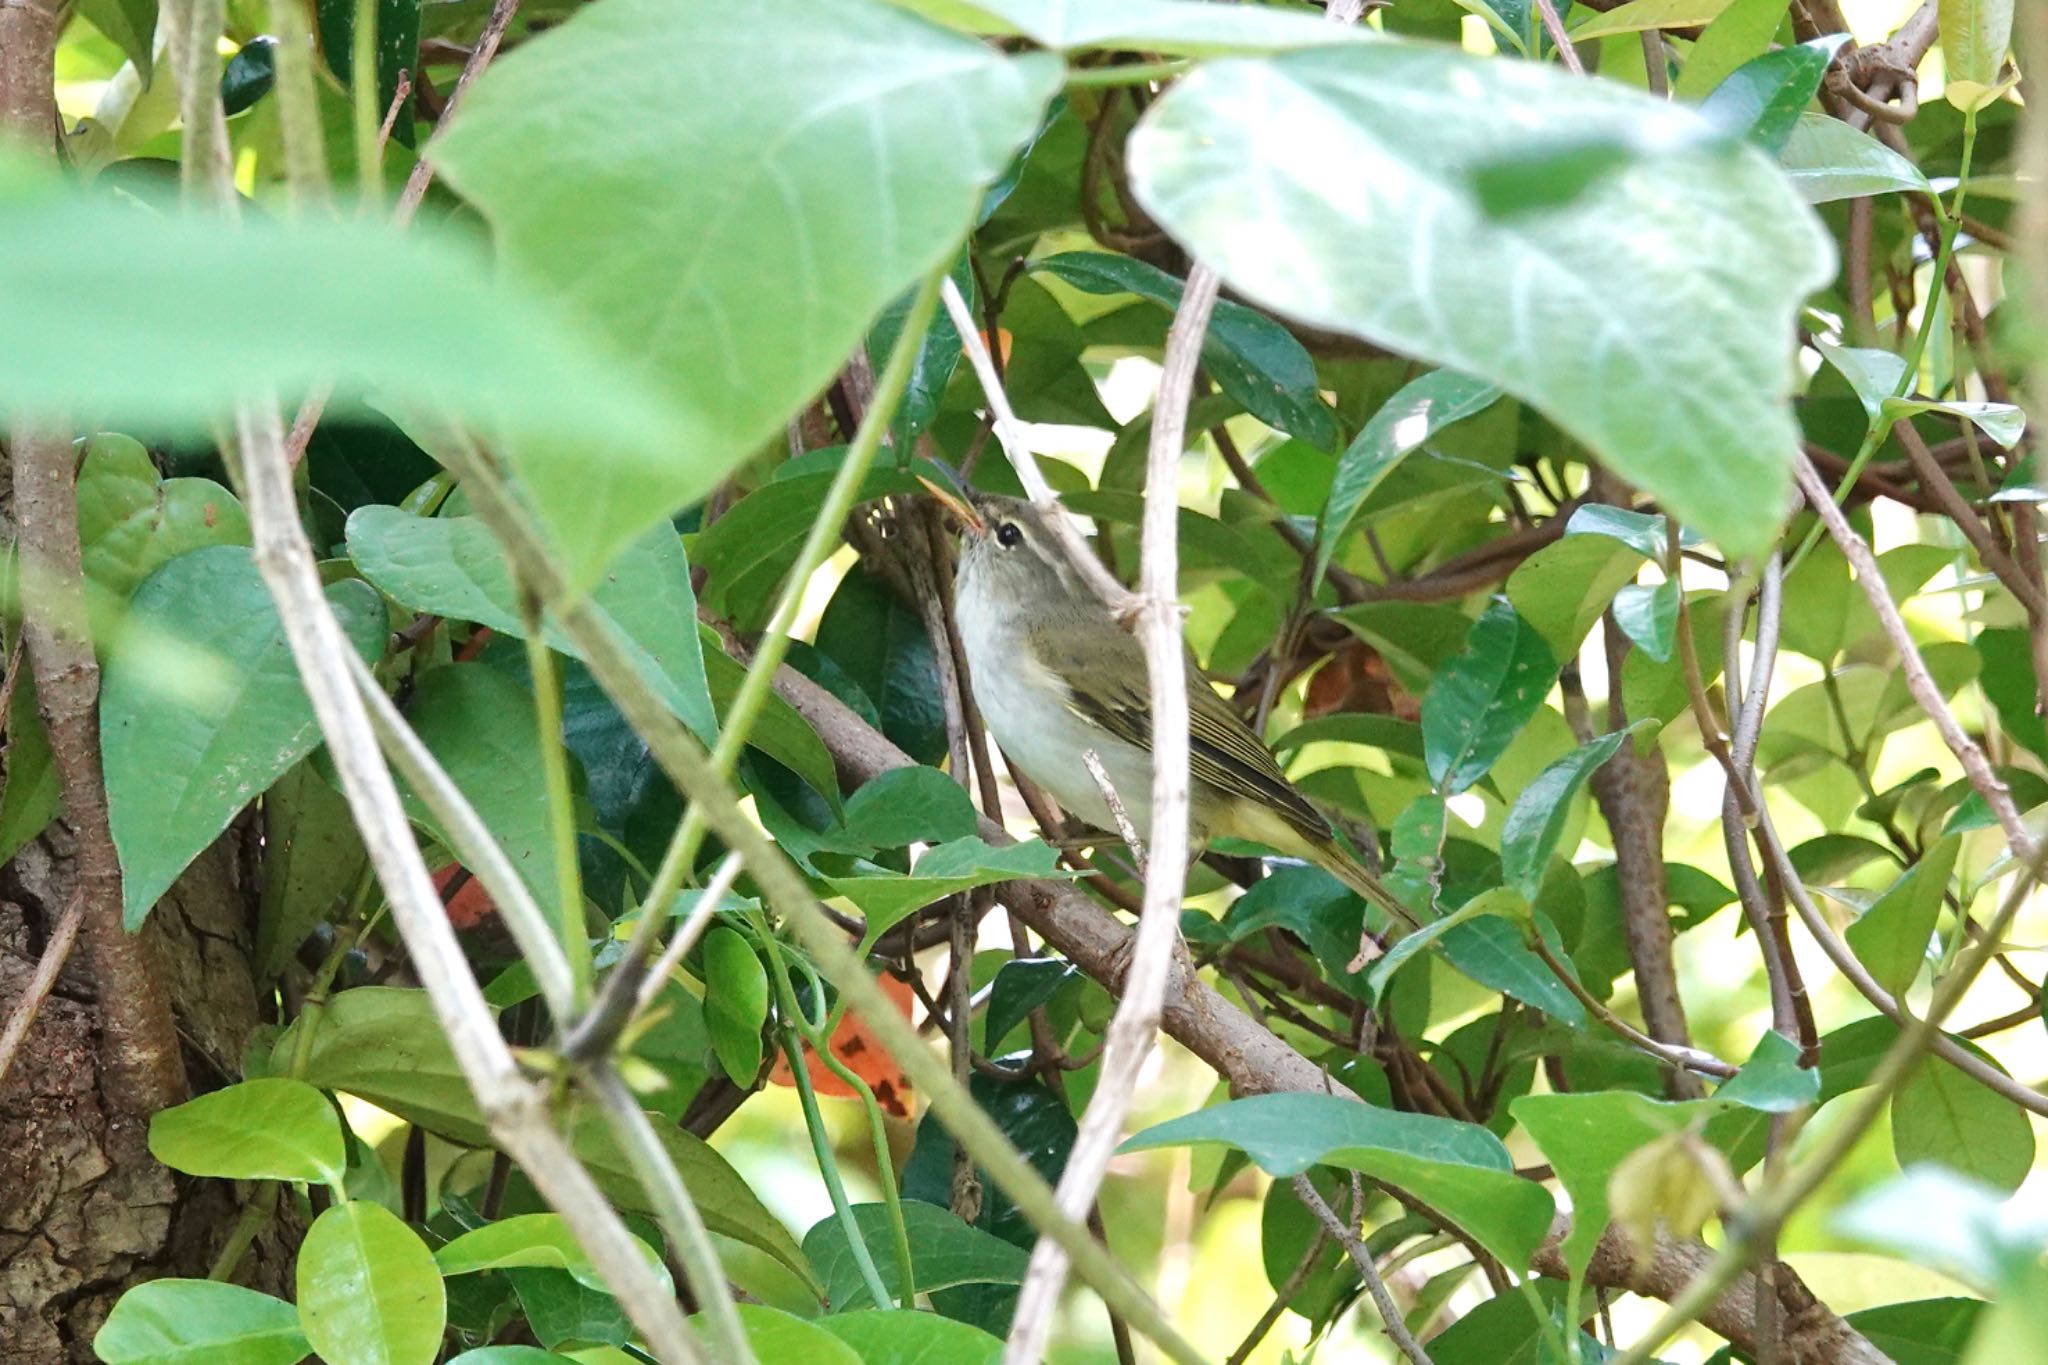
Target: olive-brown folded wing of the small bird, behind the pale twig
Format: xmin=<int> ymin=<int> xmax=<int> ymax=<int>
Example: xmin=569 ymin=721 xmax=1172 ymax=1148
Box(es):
xmin=1030 ymin=630 xmax=1329 ymax=843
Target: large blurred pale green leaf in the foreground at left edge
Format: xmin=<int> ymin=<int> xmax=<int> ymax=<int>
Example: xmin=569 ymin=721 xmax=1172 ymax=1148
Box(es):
xmin=0 ymin=190 xmax=694 ymax=507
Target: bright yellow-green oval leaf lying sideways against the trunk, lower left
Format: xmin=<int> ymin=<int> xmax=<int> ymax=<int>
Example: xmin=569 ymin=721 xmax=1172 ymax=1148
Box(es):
xmin=150 ymin=1076 xmax=348 ymax=1191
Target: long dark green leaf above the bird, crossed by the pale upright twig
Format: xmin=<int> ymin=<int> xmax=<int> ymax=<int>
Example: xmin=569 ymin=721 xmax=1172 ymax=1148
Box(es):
xmin=1036 ymin=252 xmax=1337 ymax=450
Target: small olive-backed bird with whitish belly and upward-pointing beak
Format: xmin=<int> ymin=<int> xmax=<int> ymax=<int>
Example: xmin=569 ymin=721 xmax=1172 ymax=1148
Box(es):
xmin=926 ymin=481 xmax=1415 ymax=941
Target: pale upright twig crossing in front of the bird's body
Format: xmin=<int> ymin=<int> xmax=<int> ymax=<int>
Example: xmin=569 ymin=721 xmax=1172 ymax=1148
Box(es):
xmin=1004 ymin=266 xmax=1221 ymax=1365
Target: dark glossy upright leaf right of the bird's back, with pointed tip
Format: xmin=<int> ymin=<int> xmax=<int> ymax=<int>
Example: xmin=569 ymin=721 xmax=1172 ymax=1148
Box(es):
xmin=1421 ymin=602 xmax=1556 ymax=796
